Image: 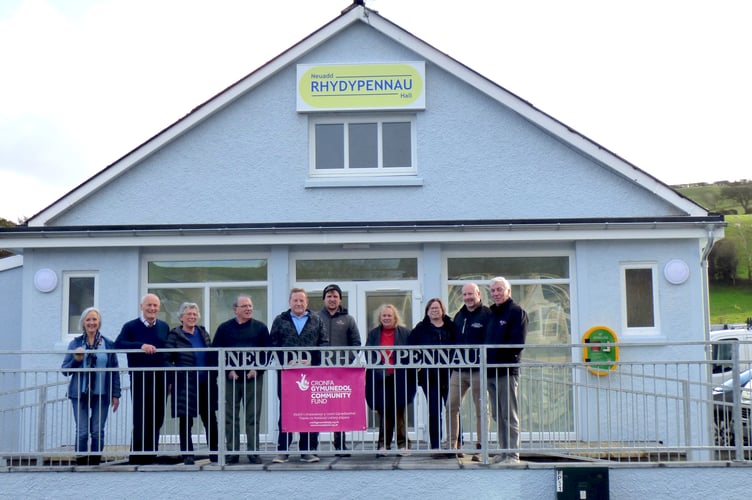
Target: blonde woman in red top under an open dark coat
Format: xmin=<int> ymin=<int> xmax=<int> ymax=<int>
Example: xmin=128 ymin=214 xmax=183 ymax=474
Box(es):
xmin=366 ymin=304 xmax=416 ymax=455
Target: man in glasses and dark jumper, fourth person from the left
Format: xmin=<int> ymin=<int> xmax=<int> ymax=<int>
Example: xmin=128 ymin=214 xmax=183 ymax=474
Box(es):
xmin=212 ymin=295 xmax=271 ymax=464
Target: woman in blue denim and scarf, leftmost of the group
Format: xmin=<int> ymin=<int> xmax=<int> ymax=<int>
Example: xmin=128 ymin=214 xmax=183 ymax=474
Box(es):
xmin=62 ymin=307 xmax=120 ymax=465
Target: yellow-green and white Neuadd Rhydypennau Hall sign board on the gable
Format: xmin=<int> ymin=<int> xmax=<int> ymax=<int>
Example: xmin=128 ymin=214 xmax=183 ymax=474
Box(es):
xmin=297 ymin=61 xmax=426 ymax=112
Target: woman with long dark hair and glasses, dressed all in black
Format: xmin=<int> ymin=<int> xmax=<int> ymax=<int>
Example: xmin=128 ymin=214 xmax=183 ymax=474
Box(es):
xmin=408 ymin=298 xmax=454 ymax=458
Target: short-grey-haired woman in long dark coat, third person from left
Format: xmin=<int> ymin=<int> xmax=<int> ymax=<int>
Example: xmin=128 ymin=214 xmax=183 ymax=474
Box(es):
xmin=166 ymin=302 xmax=218 ymax=465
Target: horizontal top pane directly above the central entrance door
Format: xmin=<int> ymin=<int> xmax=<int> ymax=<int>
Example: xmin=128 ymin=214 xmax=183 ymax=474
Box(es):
xmin=295 ymin=259 xmax=418 ymax=281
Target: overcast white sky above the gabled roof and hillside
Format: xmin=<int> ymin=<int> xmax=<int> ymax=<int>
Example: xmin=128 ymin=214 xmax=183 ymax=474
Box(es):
xmin=0 ymin=0 xmax=752 ymax=222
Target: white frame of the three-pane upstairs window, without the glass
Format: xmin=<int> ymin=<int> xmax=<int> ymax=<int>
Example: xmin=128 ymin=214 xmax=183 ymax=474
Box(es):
xmin=308 ymin=113 xmax=418 ymax=178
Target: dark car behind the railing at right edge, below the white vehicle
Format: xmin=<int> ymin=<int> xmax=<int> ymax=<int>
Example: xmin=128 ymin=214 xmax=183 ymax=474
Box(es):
xmin=713 ymin=370 xmax=752 ymax=446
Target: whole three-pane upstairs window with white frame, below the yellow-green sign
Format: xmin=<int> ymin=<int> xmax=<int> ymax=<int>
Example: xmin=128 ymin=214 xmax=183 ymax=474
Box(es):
xmin=310 ymin=115 xmax=416 ymax=176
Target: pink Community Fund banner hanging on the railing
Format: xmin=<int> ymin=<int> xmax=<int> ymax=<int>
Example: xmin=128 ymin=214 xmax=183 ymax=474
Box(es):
xmin=282 ymin=368 xmax=366 ymax=432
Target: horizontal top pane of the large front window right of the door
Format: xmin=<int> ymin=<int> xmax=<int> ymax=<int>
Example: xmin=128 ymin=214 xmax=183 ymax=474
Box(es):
xmin=447 ymin=256 xmax=569 ymax=284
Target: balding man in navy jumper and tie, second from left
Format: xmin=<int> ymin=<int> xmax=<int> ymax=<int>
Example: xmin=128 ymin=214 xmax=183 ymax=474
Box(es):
xmin=115 ymin=293 xmax=170 ymax=465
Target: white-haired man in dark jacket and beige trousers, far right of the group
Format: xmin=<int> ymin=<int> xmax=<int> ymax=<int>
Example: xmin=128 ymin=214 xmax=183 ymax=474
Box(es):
xmin=486 ymin=277 xmax=527 ymax=464
